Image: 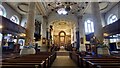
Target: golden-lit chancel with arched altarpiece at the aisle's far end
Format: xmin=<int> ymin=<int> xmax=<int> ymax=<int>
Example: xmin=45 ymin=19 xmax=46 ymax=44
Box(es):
xmin=51 ymin=20 xmax=75 ymax=46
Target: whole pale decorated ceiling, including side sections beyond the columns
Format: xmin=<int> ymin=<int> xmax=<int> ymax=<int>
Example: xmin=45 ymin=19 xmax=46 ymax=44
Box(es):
xmin=7 ymin=2 xmax=116 ymax=16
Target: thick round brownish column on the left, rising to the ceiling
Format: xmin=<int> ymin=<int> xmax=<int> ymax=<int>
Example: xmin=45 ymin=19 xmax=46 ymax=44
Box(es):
xmin=25 ymin=2 xmax=35 ymax=45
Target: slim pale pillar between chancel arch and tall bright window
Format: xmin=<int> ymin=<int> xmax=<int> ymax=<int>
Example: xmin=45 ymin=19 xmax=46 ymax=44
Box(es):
xmin=79 ymin=16 xmax=86 ymax=51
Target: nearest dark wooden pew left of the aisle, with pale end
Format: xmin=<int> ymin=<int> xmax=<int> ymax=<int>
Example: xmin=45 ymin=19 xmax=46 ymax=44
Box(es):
xmin=2 ymin=55 xmax=46 ymax=68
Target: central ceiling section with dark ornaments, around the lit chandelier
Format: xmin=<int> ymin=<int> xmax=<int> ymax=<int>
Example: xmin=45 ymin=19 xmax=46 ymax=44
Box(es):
xmin=45 ymin=2 xmax=88 ymax=14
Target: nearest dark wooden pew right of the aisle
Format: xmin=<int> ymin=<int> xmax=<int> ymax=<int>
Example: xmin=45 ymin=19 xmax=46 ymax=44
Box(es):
xmin=83 ymin=57 xmax=120 ymax=68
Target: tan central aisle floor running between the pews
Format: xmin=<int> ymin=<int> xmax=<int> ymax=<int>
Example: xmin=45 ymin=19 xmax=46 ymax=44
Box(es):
xmin=51 ymin=48 xmax=78 ymax=68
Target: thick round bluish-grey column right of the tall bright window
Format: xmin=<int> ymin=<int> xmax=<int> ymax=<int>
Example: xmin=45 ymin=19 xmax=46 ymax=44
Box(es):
xmin=91 ymin=2 xmax=103 ymax=42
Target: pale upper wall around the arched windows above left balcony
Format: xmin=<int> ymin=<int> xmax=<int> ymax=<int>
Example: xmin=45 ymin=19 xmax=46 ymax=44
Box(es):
xmin=2 ymin=2 xmax=22 ymax=24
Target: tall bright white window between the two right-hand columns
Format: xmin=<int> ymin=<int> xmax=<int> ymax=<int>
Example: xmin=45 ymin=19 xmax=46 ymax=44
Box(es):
xmin=85 ymin=20 xmax=94 ymax=34
